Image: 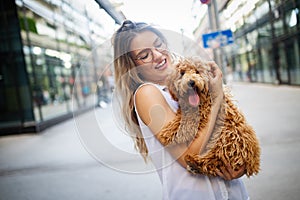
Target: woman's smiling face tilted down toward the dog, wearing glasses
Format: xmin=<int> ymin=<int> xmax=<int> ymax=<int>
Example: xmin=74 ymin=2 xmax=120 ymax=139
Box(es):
xmin=130 ymin=31 xmax=171 ymax=85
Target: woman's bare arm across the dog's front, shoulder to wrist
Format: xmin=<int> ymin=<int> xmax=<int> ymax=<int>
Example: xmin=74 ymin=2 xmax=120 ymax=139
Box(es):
xmin=136 ymin=85 xmax=220 ymax=167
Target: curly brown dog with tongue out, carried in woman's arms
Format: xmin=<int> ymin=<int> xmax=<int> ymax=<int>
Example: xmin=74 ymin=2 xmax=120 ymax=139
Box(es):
xmin=157 ymin=58 xmax=260 ymax=177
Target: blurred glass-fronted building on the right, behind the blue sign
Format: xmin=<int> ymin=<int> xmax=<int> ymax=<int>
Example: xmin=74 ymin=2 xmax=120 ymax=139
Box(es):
xmin=225 ymin=0 xmax=300 ymax=85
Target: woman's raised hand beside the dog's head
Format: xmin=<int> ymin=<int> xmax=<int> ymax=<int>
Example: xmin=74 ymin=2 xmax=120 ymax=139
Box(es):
xmin=206 ymin=61 xmax=223 ymax=102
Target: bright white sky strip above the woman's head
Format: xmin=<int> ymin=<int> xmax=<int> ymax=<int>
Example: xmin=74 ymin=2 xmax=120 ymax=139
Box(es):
xmin=121 ymin=0 xmax=200 ymax=37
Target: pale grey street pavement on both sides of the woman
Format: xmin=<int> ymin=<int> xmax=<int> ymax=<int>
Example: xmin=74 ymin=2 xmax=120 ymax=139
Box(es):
xmin=0 ymin=83 xmax=300 ymax=200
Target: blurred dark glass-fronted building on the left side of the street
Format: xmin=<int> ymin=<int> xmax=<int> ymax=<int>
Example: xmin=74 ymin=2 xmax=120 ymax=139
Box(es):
xmin=0 ymin=0 xmax=124 ymax=135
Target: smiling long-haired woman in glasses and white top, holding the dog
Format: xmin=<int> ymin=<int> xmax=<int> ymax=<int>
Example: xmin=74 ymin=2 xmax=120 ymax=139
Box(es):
xmin=113 ymin=20 xmax=248 ymax=200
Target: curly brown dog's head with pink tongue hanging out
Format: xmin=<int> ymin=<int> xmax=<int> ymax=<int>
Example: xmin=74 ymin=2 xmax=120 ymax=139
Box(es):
xmin=167 ymin=58 xmax=210 ymax=107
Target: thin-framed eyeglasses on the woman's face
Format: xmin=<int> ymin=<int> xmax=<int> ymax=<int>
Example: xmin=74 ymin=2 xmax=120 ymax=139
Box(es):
xmin=134 ymin=41 xmax=168 ymax=63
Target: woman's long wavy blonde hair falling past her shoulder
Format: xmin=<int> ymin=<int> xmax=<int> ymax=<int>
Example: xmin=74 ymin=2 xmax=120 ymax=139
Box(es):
xmin=112 ymin=20 xmax=167 ymax=161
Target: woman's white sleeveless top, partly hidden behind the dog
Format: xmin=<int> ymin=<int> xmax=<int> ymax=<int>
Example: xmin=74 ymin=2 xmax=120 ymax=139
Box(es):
xmin=134 ymin=83 xmax=250 ymax=200
